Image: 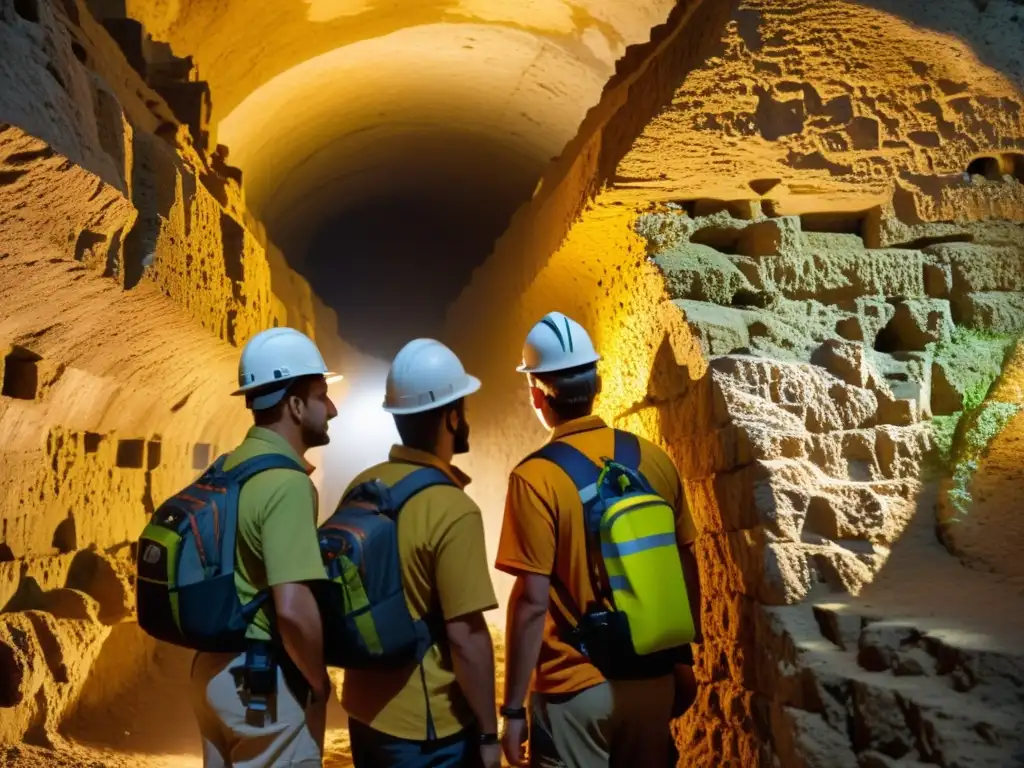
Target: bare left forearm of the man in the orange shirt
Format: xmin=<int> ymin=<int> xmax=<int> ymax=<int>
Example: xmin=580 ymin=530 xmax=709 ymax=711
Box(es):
xmin=505 ymin=573 xmax=551 ymax=709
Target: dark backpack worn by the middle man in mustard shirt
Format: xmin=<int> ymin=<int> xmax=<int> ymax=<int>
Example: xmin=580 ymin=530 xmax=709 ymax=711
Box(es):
xmin=316 ymin=467 xmax=455 ymax=669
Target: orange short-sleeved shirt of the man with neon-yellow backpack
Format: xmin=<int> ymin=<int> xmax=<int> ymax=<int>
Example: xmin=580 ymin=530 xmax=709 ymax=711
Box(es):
xmin=495 ymin=416 xmax=696 ymax=693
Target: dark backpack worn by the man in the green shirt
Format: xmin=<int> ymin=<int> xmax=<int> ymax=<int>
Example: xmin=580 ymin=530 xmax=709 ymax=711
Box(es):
xmin=136 ymin=454 xmax=304 ymax=652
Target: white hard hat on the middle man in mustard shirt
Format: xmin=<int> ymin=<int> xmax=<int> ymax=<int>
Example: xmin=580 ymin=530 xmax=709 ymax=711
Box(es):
xmin=384 ymin=339 xmax=480 ymax=416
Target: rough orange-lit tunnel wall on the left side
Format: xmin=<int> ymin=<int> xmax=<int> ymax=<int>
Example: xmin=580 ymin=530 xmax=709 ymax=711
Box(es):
xmin=0 ymin=0 xmax=345 ymax=745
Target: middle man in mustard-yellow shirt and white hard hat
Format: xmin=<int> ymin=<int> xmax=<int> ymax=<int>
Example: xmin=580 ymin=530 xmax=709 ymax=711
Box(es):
xmin=342 ymin=339 xmax=501 ymax=768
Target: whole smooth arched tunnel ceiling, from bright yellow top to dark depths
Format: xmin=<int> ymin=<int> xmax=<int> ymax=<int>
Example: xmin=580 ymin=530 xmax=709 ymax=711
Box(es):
xmin=128 ymin=0 xmax=675 ymax=356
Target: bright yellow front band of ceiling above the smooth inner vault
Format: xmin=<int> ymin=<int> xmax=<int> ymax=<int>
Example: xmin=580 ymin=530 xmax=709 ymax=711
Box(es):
xmin=127 ymin=0 xmax=675 ymax=128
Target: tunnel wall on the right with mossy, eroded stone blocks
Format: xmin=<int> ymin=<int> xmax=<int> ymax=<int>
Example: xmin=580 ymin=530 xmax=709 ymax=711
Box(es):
xmin=447 ymin=0 xmax=1024 ymax=768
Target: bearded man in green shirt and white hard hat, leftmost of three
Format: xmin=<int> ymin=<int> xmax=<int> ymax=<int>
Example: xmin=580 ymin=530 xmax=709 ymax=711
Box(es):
xmin=191 ymin=328 xmax=338 ymax=768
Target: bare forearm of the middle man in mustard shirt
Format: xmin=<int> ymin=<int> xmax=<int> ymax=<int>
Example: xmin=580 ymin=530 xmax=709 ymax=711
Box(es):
xmin=444 ymin=611 xmax=498 ymax=733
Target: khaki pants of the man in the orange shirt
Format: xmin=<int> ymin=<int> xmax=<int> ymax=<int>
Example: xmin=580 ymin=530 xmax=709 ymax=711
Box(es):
xmin=529 ymin=675 xmax=675 ymax=768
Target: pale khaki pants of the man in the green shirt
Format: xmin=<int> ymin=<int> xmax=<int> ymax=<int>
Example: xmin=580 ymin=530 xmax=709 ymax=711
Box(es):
xmin=191 ymin=653 xmax=323 ymax=768
